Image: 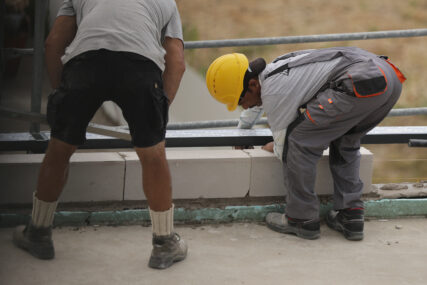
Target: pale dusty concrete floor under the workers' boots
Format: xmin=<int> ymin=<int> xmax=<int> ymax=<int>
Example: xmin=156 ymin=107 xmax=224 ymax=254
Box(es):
xmin=0 ymin=218 xmax=427 ymax=285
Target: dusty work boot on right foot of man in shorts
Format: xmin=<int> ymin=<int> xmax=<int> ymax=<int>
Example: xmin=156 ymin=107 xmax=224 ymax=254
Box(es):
xmin=148 ymin=233 xmax=187 ymax=269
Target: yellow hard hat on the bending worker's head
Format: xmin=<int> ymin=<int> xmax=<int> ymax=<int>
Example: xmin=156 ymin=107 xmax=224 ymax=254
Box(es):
xmin=206 ymin=53 xmax=249 ymax=111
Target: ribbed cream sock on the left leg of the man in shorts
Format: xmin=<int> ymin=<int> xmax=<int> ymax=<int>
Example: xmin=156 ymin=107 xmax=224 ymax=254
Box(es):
xmin=31 ymin=192 xmax=58 ymax=228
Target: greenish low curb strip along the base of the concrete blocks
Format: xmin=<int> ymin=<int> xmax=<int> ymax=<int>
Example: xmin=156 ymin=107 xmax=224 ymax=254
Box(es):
xmin=0 ymin=198 xmax=427 ymax=227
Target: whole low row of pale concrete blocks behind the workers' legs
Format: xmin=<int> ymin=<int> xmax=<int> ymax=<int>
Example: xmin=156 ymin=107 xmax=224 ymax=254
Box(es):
xmin=0 ymin=148 xmax=373 ymax=204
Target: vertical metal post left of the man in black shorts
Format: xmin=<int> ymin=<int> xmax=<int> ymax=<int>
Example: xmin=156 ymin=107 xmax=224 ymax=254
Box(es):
xmin=30 ymin=0 xmax=49 ymax=135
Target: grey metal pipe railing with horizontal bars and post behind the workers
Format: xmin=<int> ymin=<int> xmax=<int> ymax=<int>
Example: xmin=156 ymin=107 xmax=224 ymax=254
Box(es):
xmin=0 ymin=0 xmax=427 ymax=139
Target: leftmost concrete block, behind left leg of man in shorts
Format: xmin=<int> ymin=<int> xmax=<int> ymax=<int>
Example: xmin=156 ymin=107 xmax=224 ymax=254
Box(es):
xmin=0 ymin=152 xmax=125 ymax=204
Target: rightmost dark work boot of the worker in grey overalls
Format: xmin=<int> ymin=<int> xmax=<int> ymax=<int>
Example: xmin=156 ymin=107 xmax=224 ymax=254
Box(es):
xmin=326 ymin=208 xmax=364 ymax=240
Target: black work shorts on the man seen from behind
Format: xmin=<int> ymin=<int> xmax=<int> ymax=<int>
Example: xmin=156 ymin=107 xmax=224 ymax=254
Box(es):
xmin=47 ymin=50 xmax=169 ymax=147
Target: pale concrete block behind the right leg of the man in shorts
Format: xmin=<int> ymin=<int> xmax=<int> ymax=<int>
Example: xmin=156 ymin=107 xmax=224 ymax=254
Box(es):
xmin=120 ymin=150 xmax=251 ymax=200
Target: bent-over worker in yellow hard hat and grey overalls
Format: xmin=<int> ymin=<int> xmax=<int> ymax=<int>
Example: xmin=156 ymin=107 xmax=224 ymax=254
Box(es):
xmin=206 ymin=47 xmax=405 ymax=240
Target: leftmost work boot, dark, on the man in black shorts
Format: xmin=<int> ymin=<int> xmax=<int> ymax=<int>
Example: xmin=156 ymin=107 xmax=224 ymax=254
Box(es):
xmin=13 ymin=223 xmax=55 ymax=259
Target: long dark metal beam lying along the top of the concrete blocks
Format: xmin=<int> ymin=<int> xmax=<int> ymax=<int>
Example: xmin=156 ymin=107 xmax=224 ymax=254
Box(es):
xmin=0 ymin=125 xmax=427 ymax=153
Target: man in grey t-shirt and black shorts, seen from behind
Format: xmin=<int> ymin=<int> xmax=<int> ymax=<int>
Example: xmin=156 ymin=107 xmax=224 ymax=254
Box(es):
xmin=13 ymin=0 xmax=187 ymax=269
